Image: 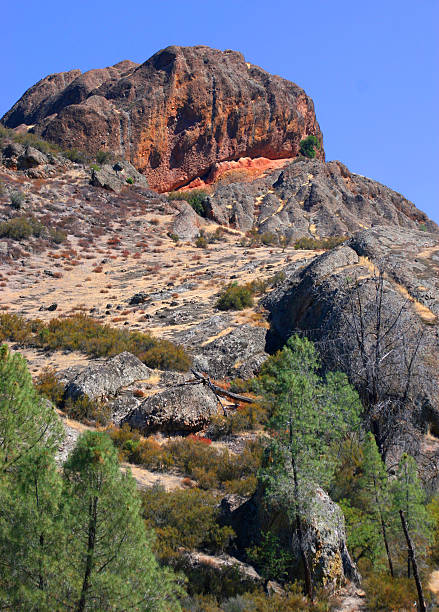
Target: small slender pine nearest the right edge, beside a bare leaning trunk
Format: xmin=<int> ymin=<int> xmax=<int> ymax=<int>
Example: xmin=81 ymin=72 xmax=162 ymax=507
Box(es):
xmin=392 ymin=453 xmax=432 ymax=578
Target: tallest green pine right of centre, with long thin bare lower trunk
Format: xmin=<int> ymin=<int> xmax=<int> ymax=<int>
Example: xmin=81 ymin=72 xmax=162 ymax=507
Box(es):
xmin=260 ymin=337 xmax=360 ymax=596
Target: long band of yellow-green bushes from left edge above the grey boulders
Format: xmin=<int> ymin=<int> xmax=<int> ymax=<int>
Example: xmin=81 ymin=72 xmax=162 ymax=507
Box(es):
xmin=0 ymin=313 xmax=191 ymax=371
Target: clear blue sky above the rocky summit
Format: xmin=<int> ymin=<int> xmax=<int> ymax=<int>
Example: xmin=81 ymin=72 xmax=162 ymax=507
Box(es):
xmin=0 ymin=0 xmax=439 ymax=222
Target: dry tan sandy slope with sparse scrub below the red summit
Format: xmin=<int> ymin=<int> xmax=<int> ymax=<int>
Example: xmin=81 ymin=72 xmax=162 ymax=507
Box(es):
xmin=0 ymin=160 xmax=315 ymax=373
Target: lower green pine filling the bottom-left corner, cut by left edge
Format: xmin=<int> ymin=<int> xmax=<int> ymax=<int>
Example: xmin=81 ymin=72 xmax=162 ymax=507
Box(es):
xmin=0 ymin=448 xmax=65 ymax=612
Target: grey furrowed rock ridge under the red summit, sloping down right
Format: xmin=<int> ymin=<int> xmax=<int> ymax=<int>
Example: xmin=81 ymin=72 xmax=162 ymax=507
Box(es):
xmin=206 ymin=159 xmax=439 ymax=242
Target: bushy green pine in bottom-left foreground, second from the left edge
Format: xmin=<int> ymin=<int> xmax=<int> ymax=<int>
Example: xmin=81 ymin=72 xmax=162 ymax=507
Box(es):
xmin=58 ymin=432 xmax=181 ymax=612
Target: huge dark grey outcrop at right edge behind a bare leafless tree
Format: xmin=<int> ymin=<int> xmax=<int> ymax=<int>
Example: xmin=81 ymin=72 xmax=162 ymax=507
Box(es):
xmin=263 ymin=227 xmax=439 ymax=454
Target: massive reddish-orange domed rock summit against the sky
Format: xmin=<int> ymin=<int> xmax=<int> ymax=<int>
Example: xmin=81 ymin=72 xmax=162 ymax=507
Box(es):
xmin=2 ymin=46 xmax=324 ymax=191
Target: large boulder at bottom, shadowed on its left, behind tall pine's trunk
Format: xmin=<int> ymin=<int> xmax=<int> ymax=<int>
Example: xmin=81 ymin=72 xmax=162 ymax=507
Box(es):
xmin=221 ymin=479 xmax=360 ymax=590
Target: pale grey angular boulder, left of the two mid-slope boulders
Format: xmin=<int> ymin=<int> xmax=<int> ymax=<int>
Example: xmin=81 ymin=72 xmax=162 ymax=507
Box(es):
xmin=64 ymin=351 xmax=152 ymax=400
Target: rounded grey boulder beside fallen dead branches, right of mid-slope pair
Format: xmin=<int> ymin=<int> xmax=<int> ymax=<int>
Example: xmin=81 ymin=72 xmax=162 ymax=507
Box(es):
xmin=121 ymin=385 xmax=217 ymax=433
